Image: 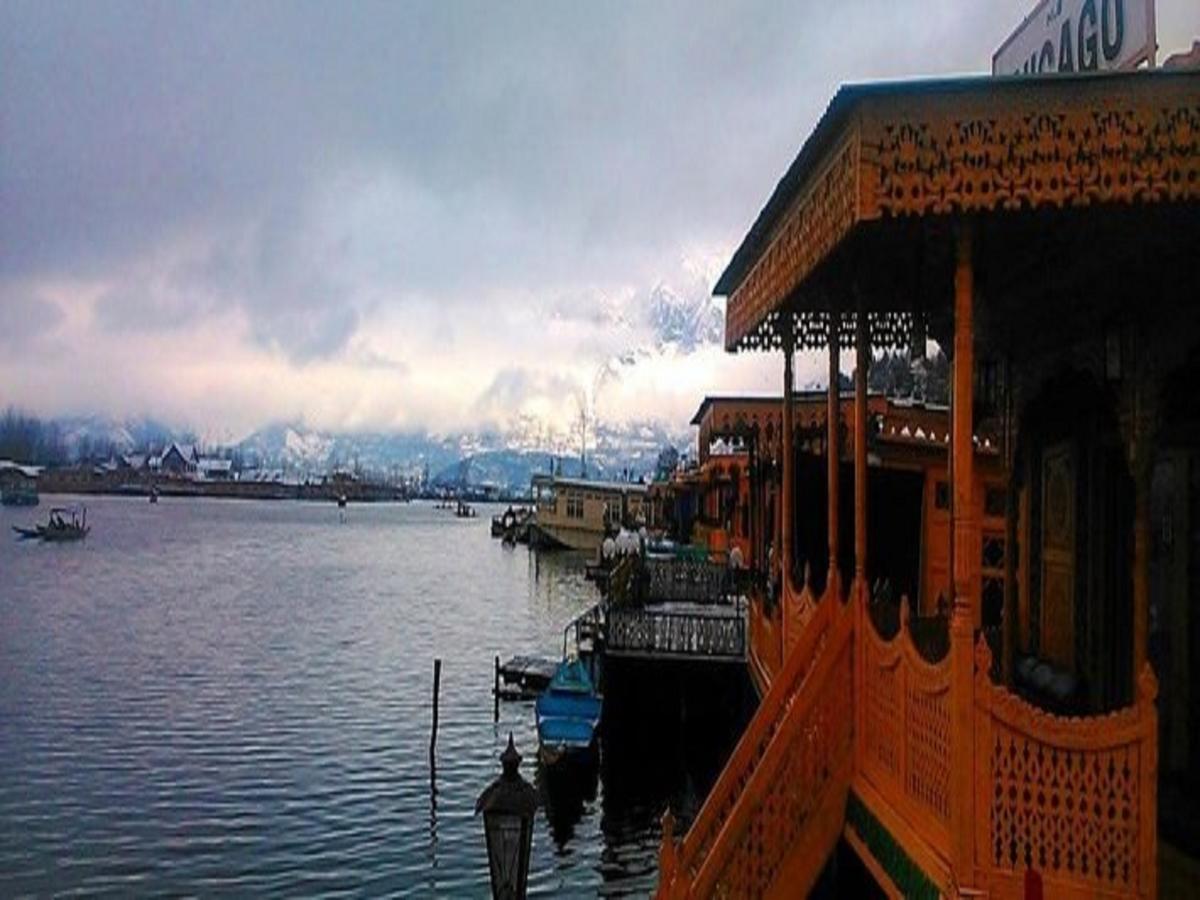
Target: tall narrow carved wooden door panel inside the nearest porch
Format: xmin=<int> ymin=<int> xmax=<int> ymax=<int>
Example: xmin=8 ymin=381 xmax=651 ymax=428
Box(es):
xmin=1040 ymin=442 xmax=1079 ymax=671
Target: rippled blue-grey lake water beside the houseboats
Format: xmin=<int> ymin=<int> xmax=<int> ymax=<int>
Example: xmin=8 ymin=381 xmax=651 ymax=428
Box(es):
xmin=0 ymin=497 xmax=736 ymax=896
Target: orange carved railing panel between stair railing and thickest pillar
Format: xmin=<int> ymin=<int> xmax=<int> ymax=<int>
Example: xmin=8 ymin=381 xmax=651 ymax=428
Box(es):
xmin=854 ymin=600 xmax=953 ymax=859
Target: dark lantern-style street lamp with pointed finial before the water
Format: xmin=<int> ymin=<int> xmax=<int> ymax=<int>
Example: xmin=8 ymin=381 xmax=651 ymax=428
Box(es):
xmin=475 ymin=732 xmax=538 ymax=900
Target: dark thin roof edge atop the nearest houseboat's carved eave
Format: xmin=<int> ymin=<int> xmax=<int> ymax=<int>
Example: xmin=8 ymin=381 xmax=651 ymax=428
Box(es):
xmin=713 ymin=68 xmax=1195 ymax=296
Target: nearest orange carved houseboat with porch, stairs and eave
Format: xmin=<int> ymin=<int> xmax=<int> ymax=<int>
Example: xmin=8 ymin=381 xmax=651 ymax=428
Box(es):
xmin=659 ymin=72 xmax=1200 ymax=898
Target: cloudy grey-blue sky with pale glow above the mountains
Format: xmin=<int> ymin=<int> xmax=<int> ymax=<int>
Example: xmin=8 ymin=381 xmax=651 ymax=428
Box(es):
xmin=0 ymin=0 xmax=1200 ymax=439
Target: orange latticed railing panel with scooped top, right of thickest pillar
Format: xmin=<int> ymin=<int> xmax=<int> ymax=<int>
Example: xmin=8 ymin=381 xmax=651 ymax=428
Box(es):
xmin=974 ymin=638 xmax=1158 ymax=896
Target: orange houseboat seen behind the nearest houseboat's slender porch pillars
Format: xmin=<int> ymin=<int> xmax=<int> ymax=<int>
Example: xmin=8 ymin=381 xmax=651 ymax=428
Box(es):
xmin=668 ymin=391 xmax=1004 ymax=694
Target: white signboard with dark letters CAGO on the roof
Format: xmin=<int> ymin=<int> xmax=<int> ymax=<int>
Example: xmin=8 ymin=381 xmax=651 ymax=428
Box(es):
xmin=991 ymin=0 xmax=1156 ymax=74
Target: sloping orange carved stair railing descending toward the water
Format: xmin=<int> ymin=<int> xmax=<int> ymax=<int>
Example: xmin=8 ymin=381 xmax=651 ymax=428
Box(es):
xmin=659 ymin=588 xmax=854 ymax=898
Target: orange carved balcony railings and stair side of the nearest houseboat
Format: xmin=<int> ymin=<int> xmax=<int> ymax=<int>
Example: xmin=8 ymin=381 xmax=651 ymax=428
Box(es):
xmin=659 ymin=590 xmax=1157 ymax=898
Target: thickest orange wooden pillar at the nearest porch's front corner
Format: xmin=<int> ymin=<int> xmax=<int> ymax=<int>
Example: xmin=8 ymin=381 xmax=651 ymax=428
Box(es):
xmin=949 ymin=222 xmax=990 ymax=887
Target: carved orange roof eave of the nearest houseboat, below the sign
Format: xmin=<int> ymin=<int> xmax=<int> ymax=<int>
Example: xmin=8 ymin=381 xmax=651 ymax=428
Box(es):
xmin=715 ymin=71 xmax=1200 ymax=350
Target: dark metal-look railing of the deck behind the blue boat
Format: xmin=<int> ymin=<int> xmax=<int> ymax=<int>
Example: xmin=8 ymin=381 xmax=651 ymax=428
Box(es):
xmin=605 ymin=606 xmax=746 ymax=661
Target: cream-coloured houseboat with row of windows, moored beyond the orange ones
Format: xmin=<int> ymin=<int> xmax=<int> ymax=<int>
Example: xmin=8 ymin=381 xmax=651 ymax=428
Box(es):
xmin=529 ymin=475 xmax=647 ymax=551
